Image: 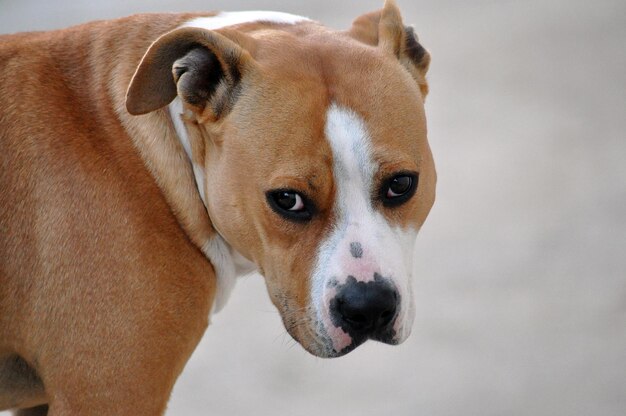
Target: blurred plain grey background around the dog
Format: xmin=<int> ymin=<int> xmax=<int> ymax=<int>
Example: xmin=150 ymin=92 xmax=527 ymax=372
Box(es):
xmin=0 ymin=0 xmax=626 ymax=416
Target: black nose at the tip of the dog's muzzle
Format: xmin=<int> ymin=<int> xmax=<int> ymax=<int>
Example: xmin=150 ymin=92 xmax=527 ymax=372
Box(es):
xmin=330 ymin=276 xmax=398 ymax=336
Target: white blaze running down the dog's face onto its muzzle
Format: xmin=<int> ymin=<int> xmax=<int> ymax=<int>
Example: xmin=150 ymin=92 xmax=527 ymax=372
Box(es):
xmin=312 ymin=104 xmax=417 ymax=348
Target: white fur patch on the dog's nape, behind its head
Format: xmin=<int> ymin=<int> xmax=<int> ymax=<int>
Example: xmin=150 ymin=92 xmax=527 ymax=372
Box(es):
xmin=183 ymin=11 xmax=309 ymax=30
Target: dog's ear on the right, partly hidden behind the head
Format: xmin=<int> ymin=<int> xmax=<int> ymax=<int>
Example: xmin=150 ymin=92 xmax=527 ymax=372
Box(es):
xmin=348 ymin=0 xmax=430 ymax=97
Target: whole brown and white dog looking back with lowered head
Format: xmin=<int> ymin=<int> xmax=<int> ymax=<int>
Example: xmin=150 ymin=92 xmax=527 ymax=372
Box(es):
xmin=0 ymin=1 xmax=435 ymax=415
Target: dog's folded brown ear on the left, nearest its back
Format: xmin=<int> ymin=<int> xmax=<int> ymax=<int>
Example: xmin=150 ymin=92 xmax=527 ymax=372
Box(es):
xmin=126 ymin=28 xmax=254 ymax=120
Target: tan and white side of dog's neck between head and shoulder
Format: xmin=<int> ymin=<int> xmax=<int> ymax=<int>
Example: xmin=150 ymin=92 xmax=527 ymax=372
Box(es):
xmin=115 ymin=75 xmax=250 ymax=312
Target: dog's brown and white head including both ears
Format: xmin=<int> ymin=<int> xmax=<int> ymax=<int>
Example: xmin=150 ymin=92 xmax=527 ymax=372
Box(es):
xmin=127 ymin=2 xmax=435 ymax=357
